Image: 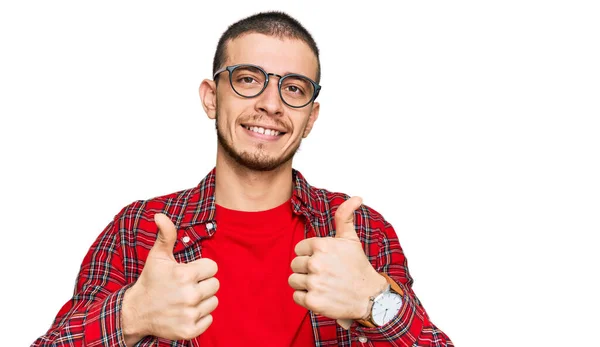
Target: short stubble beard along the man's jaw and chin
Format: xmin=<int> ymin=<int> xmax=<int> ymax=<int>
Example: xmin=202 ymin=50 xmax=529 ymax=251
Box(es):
xmin=215 ymin=111 xmax=302 ymax=171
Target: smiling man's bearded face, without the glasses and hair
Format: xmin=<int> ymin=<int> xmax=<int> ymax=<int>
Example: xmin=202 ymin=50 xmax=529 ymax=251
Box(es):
xmin=201 ymin=33 xmax=319 ymax=171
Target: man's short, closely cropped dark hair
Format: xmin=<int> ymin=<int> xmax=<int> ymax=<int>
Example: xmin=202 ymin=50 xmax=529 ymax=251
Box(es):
xmin=213 ymin=11 xmax=321 ymax=83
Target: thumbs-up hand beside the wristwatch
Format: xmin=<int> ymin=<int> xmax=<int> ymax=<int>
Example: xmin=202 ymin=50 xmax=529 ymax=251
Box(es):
xmin=288 ymin=197 xmax=386 ymax=329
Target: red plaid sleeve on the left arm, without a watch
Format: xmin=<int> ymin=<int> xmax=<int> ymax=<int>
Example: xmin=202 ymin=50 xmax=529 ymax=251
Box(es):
xmin=31 ymin=215 xmax=129 ymax=347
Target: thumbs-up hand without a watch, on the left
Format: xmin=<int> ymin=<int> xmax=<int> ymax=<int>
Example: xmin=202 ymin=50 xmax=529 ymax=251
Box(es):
xmin=122 ymin=213 xmax=219 ymax=346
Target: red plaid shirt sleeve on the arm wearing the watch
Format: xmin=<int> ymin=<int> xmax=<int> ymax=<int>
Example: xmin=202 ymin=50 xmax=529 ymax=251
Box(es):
xmin=352 ymin=222 xmax=454 ymax=347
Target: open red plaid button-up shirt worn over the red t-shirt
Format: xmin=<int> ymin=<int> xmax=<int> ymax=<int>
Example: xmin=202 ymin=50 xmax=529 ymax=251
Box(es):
xmin=32 ymin=169 xmax=453 ymax=347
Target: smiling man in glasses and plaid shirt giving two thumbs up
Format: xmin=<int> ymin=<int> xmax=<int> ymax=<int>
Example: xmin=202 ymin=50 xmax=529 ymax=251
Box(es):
xmin=33 ymin=12 xmax=452 ymax=347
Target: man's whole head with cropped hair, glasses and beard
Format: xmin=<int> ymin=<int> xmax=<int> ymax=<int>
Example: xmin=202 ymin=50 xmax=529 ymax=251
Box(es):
xmin=200 ymin=12 xmax=320 ymax=171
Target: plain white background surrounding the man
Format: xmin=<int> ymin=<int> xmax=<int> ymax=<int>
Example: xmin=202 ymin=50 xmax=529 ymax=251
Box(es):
xmin=0 ymin=0 xmax=600 ymax=347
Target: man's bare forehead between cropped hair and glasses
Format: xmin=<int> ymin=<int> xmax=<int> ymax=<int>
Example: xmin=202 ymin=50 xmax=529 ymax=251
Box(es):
xmin=225 ymin=33 xmax=317 ymax=79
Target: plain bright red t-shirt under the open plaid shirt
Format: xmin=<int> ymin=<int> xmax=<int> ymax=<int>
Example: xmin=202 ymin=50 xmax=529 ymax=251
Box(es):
xmin=198 ymin=201 xmax=315 ymax=347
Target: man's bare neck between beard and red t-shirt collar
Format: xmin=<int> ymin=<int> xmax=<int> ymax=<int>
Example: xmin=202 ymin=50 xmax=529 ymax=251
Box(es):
xmin=215 ymin=149 xmax=293 ymax=211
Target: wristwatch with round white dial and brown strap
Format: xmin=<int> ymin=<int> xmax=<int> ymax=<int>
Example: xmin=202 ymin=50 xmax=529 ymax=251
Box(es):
xmin=356 ymin=272 xmax=404 ymax=328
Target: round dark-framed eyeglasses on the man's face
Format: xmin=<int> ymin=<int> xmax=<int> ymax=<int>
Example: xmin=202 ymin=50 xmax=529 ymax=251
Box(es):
xmin=213 ymin=64 xmax=321 ymax=108
